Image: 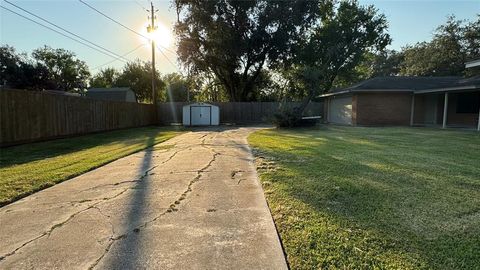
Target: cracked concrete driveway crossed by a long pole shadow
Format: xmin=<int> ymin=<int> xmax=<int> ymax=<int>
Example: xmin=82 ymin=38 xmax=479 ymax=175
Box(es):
xmin=0 ymin=128 xmax=287 ymax=269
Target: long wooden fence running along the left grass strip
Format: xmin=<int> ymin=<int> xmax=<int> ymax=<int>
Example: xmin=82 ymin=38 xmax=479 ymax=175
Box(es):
xmin=0 ymin=89 xmax=156 ymax=146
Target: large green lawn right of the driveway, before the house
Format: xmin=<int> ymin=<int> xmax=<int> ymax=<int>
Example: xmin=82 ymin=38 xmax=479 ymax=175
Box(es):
xmin=249 ymin=126 xmax=480 ymax=269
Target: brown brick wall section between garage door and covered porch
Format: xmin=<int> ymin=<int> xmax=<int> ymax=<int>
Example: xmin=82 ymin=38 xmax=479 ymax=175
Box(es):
xmin=354 ymin=92 xmax=412 ymax=126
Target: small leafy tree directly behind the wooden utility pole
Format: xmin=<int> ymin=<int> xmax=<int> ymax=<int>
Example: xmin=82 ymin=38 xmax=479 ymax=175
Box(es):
xmin=115 ymin=60 xmax=165 ymax=102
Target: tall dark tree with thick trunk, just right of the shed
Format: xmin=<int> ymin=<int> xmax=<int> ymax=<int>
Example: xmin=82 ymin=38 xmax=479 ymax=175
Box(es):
xmin=175 ymin=0 xmax=326 ymax=101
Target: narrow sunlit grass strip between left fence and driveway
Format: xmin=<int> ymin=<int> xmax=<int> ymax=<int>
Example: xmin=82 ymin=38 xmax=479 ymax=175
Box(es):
xmin=0 ymin=127 xmax=180 ymax=206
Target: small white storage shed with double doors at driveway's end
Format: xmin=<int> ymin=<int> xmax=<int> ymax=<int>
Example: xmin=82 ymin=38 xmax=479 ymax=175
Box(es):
xmin=183 ymin=103 xmax=220 ymax=126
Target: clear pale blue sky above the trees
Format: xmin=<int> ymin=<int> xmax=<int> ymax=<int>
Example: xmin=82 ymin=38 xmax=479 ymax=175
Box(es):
xmin=0 ymin=0 xmax=480 ymax=73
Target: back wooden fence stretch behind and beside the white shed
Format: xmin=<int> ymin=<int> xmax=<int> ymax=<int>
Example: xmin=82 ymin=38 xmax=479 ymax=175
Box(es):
xmin=158 ymin=102 xmax=323 ymax=124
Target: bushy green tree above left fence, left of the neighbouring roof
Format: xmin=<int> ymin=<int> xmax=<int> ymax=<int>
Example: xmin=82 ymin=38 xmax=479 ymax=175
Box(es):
xmin=32 ymin=46 xmax=90 ymax=92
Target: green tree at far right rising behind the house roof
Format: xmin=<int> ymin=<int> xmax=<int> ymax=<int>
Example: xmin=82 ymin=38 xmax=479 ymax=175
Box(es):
xmin=400 ymin=16 xmax=480 ymax=76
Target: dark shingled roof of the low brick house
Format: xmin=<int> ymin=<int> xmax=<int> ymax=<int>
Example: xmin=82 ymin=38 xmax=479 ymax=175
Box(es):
xmin=320 ymin=76 xmax=480 ymax=97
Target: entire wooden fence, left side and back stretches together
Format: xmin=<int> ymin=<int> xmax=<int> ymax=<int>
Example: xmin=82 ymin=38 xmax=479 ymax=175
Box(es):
xmin=0 ymin=89 xmax=323 ymax=146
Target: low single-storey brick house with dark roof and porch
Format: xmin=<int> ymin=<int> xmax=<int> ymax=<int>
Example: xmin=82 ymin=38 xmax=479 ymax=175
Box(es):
xmin=320 ymin=77 xmax=480 ymax=130
